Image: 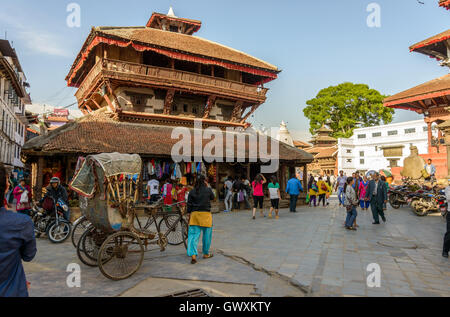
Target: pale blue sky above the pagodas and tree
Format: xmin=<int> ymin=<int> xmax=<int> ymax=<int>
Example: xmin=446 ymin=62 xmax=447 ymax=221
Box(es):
xmin=0 ymin=0 xmax=450 ymax=137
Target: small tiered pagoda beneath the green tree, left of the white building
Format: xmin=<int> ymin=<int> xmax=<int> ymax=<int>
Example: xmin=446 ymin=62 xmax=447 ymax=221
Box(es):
xmin=305 ymin=125 xmax=338 ymax=176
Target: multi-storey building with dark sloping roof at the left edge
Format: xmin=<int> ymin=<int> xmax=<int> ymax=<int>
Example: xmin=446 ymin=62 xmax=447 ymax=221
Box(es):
xmin=0 ymin=40 xmax=29 ymax=169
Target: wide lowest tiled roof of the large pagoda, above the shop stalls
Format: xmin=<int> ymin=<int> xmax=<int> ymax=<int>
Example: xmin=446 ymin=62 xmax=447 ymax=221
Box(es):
xmin=23 ymin=108 xmax=313 ymax=163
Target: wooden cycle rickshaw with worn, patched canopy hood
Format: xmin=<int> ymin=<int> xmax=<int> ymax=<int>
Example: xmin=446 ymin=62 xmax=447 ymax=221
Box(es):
xmin=70 ymin=153 xmax=188 ymax=280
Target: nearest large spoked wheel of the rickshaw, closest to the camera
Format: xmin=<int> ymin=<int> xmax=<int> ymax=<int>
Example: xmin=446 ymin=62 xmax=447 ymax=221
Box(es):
xmin=98 ymin=231 xmax=144 ymax=281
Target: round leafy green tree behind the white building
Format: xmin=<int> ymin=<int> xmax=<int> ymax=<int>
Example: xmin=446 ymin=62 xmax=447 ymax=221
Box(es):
xmin=303 ymin=83 xmax=394 ymax=138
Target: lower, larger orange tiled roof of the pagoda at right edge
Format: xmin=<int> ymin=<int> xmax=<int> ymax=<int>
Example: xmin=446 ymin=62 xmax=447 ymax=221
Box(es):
xmin=383 ymin=74 xmax=450 ymax=111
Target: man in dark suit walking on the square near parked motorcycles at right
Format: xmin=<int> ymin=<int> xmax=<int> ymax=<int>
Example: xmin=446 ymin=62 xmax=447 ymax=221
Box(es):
xmin=366 ymin=173 xmax=387 ymax=225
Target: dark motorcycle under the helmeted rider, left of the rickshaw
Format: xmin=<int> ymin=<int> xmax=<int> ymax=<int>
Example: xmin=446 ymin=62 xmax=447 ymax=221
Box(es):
xmin=31 ymin=197 xmax=72 ymax=243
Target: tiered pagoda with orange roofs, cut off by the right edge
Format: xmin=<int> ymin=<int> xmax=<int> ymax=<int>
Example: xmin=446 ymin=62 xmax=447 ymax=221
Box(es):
xmin=384 ymin=0 xmax=450 ymax=178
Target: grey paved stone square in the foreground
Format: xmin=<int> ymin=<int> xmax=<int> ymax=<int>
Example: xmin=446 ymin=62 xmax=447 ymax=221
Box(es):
xmin=25 ymin=200 xmax=450 ymax=296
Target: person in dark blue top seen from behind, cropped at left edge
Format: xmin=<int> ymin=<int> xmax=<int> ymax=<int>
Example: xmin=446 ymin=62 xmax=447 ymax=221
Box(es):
xmin=0 ymin=163 xmax=37 ymax=297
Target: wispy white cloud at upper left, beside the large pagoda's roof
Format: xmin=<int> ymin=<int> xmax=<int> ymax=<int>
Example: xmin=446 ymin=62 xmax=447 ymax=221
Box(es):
xmin=0 ymin=12 xmax=71 ymax=57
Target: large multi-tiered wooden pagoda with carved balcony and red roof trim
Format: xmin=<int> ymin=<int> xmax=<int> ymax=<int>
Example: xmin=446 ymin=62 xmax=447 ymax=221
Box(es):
xmin=25 ymin=9 xmax=313 ymax=207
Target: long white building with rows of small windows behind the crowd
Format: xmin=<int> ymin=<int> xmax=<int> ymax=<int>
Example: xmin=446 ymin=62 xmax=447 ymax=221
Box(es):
xmin=338 ymin=120 xmax=437 ymax=175
